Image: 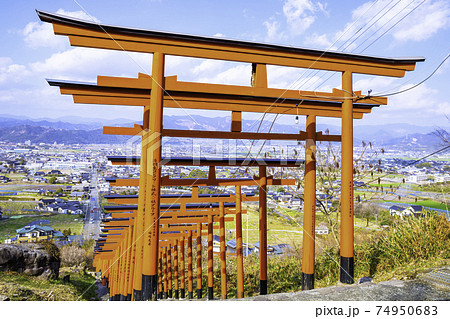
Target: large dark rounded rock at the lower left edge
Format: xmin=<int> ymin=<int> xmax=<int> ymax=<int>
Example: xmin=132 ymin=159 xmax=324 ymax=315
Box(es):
xmin=0 ymin=243 xmax=60 ymax=278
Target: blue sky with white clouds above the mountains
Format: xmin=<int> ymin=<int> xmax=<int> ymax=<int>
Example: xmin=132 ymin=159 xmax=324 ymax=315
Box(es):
xmin=0 ymin=0 xmax=450 ymax=127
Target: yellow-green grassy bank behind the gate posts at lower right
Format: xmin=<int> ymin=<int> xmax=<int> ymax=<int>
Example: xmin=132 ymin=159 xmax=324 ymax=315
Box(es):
xmin=202 ymin=215 xmax=450 ymax=298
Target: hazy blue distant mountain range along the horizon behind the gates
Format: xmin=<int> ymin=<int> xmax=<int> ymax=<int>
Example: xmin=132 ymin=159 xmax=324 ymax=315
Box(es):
xmin=0 ymin=115 xmax=441 ymax=148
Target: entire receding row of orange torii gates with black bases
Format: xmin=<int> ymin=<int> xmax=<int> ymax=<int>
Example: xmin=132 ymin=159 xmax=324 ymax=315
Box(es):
xmin=37 ymin=11 xmax=424 ymax=300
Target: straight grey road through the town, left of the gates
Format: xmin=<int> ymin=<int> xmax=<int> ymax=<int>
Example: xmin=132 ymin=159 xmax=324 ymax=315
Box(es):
xmin=83 ymin=164 xmax=102 ymax=239
